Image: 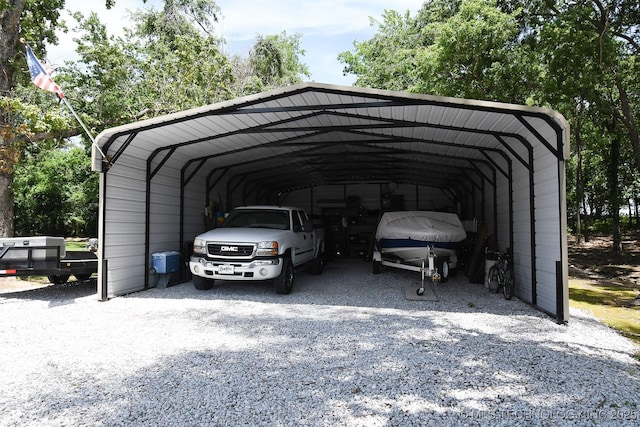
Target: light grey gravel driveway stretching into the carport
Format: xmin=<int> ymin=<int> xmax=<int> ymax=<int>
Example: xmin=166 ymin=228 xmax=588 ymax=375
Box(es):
xmin=0 ymin=260 xmax=640 ymax=426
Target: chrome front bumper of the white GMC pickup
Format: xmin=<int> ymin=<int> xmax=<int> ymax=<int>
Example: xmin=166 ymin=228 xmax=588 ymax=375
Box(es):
xmin=189 ymin=256 xmax=282 ymax=280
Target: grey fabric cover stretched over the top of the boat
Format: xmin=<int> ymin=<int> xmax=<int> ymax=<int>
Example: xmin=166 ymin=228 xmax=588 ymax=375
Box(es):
xmin=376 ymin=211 xmax=467 ymax=242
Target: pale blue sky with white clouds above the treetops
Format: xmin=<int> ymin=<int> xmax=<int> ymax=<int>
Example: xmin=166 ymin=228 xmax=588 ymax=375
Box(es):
xmin=47 ymin=0 xmax=424 ymax=86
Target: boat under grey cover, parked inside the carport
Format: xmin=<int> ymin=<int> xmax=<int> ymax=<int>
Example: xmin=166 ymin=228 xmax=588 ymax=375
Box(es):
xmin=374 ymin=211 xmax=467 ymax=279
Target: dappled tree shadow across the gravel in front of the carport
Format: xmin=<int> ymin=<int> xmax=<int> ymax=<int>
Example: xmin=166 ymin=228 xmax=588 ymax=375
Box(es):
xmin=16 ymin=289 xmax=640 ymax=426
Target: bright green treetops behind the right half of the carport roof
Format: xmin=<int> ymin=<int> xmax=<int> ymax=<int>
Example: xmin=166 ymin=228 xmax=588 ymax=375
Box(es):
xmin=339 ymin=0 xmax=540 ymax=103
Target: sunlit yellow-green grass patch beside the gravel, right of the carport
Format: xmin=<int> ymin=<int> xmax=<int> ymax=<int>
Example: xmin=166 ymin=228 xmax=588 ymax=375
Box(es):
xmin=569 ymin=278 xmax=640 ymax=344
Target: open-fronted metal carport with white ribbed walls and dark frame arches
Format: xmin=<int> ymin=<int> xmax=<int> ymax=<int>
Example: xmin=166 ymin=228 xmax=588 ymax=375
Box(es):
xmin=93 ymin=83 xmax=569 ymax=322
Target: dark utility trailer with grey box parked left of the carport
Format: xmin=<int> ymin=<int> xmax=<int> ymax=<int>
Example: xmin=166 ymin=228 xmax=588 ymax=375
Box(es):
xmin=0 ymin=236 xmax=98 ymax=284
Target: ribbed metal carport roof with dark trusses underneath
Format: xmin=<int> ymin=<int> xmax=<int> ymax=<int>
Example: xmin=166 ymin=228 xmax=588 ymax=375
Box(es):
xmin=94 ymin=83 xmax=567 ymax=199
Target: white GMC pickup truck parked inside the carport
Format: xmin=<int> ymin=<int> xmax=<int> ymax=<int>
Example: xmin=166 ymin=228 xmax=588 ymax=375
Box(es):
xmin=189 ymin=206 xmax=324 ymax=294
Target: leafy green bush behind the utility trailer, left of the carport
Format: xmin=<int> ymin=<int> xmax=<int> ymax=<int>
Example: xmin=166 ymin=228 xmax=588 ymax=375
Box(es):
xmin=13 ymin=147 xmax=98 ymax=236
